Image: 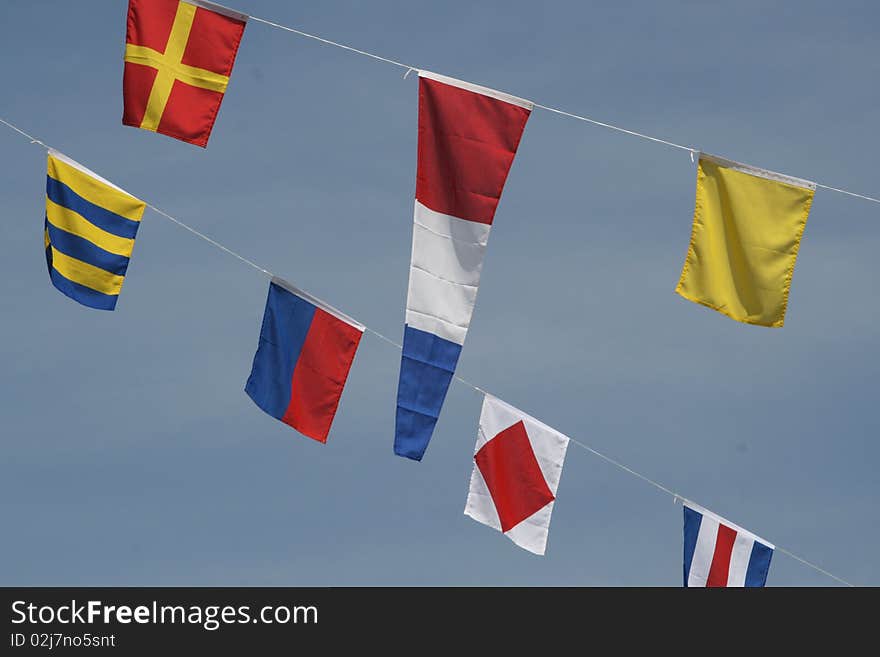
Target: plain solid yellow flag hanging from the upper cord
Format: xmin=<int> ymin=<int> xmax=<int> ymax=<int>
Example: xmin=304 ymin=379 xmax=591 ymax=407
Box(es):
xmin=675 ymin=153 xmax=816 ymax=327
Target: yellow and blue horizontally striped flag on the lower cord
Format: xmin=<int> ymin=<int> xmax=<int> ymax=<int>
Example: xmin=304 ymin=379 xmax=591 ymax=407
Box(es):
xmin=44 ymin=150 xmax=146 ymax=310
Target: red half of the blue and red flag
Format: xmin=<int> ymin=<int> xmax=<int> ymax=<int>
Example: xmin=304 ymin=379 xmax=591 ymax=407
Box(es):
xmin=281 ymin=308 xmax=363 ymax=443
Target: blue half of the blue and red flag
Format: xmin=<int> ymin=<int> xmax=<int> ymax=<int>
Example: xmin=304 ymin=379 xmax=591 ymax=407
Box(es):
xmin=244 ymin=283 xmax=315 ymax=420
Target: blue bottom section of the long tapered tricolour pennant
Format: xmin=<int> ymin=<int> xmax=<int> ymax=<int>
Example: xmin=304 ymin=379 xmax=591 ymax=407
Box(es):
xmin=394 ymin=326 xmax=461 ymax=461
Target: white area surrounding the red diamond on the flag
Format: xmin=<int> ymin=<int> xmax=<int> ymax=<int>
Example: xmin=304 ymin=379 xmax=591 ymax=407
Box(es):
xmin=464 ymin=395 xmax=569 ymax=555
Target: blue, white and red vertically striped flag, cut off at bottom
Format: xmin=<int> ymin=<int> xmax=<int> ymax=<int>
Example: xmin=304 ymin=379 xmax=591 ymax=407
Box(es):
xmin=684 ymin=502 xmax=776 ymax=587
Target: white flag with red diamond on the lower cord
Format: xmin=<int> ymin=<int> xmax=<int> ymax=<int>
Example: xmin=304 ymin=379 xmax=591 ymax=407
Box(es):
xmin=464 ymin=395 xmax=568 ymax=555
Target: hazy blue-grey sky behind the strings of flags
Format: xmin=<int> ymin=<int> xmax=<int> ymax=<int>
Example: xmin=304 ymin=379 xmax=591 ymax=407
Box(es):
xmin=0 ymin=0 xmax=880 ymax=586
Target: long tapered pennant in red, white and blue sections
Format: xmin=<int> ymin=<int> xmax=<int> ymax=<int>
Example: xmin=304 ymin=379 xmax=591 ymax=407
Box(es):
xmin=394 ymin=71 xmax=532 ymax=461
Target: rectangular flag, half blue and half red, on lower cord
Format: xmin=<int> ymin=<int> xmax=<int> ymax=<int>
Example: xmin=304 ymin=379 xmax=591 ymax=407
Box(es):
xmin=245 ymin=278 xmax=364 ymax=443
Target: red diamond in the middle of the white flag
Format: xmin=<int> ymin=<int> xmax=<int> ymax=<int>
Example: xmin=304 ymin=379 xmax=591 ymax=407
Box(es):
xmin=474 ymin=421 xmax=556 ymax=532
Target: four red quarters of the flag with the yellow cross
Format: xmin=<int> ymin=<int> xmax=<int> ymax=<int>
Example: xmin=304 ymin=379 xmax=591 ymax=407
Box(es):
xmin=122 ymin=0 xmax=245 ymax=147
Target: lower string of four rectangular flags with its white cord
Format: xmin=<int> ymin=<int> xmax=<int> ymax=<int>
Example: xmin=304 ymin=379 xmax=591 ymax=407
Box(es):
xmin=0 ymin=111 xmax=855 ymax=587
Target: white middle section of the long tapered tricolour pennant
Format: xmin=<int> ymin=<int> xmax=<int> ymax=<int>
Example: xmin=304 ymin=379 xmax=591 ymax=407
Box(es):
xmin=406 ymin=201 xmax=491 ymax=344
